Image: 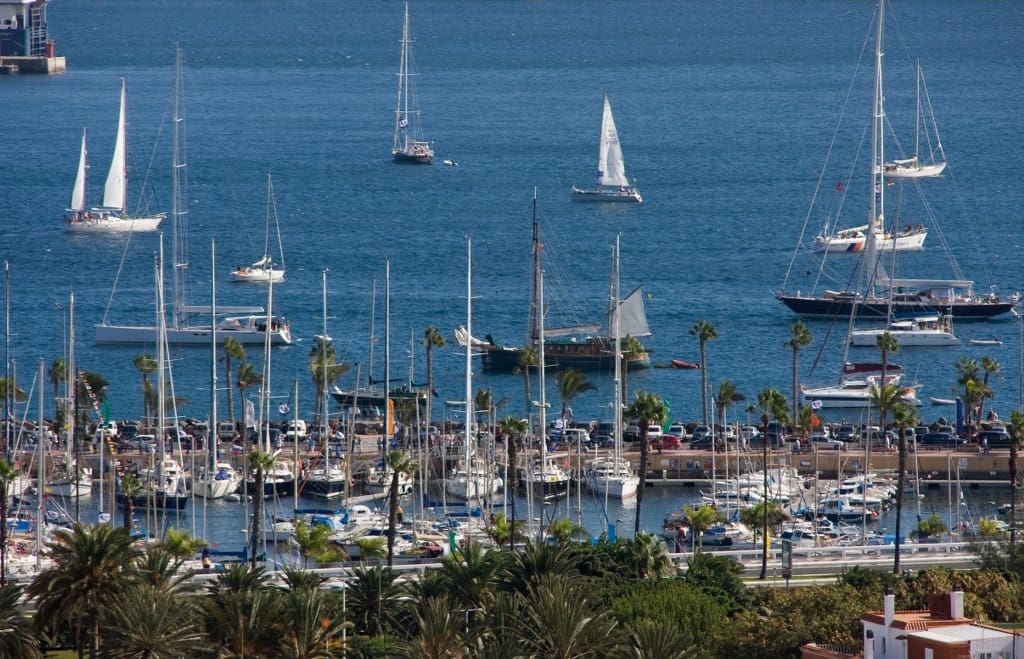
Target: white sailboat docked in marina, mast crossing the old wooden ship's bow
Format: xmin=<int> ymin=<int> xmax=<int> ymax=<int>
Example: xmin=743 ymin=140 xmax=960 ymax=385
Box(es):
xmin=444 ymin=238 xmax=504 ymax=501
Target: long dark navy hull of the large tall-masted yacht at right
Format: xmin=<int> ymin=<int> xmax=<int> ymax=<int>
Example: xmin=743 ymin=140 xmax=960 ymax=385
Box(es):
xmin=776 ymin=294 xmax=1015 ymax=320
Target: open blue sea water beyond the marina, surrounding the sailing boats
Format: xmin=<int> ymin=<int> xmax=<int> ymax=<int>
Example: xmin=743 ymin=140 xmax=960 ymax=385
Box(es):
xmin=0 ymin=0 xmax=1024 ymax=544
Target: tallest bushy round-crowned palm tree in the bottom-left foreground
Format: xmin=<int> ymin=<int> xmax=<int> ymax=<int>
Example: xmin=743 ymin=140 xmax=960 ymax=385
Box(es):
xmin=26 ymin=524 xmax=141 ymax=657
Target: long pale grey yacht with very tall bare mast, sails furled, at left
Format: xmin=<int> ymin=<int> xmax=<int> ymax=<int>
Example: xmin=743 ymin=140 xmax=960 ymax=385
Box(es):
xmin=95 ymin=50 xmax=292 ymax=345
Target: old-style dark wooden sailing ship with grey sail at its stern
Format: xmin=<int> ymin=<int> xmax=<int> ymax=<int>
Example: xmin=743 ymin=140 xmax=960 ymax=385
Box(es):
xmin=455 ymin=194 xmax=650 ymax=372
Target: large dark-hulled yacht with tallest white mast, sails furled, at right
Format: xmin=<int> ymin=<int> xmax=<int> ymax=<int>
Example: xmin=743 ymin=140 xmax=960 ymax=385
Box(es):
xmin=775 ymin=2 xmax=1020 ymax=319
